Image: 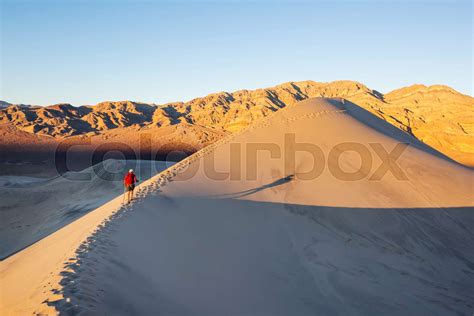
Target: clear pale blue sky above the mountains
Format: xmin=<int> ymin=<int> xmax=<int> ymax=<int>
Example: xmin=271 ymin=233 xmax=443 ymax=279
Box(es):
xmin=0 ymin=0 xmax=473 ymax=105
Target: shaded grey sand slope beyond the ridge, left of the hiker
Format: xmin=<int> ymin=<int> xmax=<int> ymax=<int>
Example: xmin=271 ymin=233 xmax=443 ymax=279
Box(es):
xmin=0 ymin=159 xmax=171 ymax=260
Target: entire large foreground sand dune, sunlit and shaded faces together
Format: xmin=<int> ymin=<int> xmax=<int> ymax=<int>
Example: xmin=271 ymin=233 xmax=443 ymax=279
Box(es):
xmin=0 ymin=99 xmax=474 ymax=315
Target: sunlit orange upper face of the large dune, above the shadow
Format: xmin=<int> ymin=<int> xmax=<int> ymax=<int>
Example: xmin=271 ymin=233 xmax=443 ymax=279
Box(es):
xmin=164 ymin=98 xmax=473 ymax=208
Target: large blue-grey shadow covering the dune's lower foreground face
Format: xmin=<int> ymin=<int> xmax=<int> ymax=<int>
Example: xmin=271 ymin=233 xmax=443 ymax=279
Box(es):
xmin=49 ymin=195 xmax=474 ymax=316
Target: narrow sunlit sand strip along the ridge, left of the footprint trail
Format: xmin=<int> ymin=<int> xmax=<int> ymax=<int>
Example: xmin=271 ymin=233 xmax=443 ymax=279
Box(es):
xmin=0 ymin=97 xmax=286 ymax=316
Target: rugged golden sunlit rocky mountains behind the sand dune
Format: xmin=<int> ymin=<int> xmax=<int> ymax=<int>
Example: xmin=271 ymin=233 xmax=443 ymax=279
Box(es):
xmin=0 ymin=81 xmax=474 ymax=166
